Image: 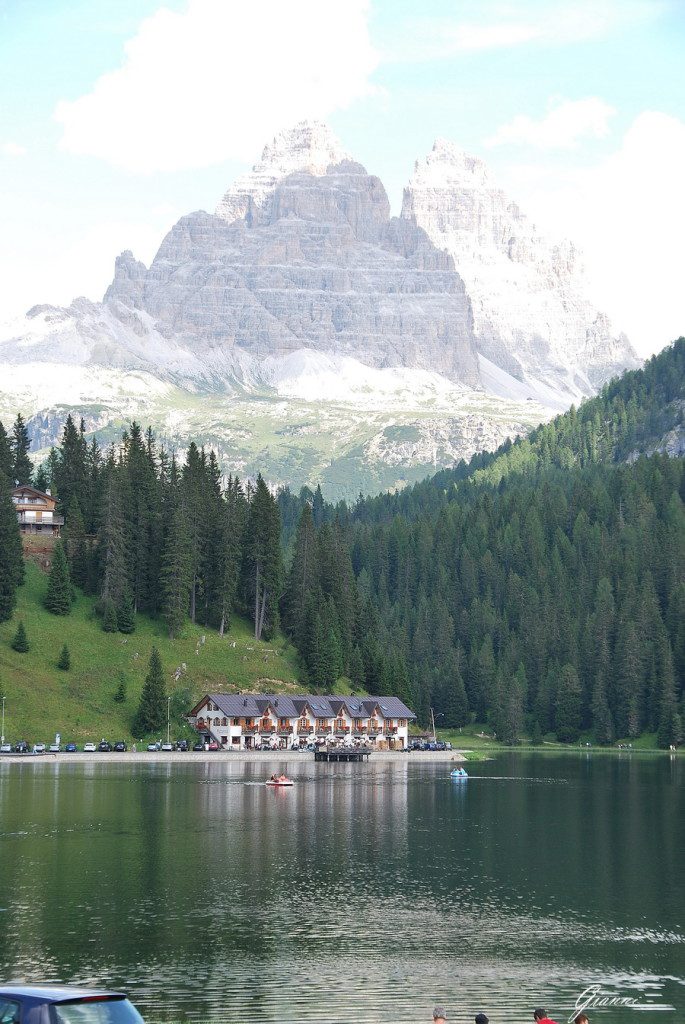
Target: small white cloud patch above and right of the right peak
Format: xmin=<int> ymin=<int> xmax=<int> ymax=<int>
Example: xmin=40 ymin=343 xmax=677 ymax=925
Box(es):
xmin=485 ymin=96 xmax=616 ymax=150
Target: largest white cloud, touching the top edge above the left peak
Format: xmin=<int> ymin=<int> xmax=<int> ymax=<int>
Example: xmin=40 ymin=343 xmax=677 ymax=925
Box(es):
xmin=55 ymin=0 xmax=377 ymax=172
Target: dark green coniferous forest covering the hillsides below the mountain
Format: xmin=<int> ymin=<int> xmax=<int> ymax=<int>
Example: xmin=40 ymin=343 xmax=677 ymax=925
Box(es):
xmin=0 ymin=339 xmax=685 ymax=746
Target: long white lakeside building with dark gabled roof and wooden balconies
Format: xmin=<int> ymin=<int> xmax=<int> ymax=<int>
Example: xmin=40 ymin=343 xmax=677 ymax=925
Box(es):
xmin=187 ymin=693 xmax=416 ymax=751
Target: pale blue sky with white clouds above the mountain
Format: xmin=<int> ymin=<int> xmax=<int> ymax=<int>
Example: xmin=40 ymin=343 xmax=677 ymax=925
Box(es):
xmin=0 ymin=0 xmax=685 ymax=355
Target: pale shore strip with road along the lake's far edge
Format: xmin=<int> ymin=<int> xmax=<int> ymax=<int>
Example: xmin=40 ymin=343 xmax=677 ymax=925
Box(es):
xmin=0 ymin=751 xmax=466 ymax=766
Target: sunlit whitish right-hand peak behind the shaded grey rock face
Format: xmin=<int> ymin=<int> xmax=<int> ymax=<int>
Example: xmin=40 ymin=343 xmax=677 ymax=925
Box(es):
xmin=402 ymin=139 xmax=639 ymax=395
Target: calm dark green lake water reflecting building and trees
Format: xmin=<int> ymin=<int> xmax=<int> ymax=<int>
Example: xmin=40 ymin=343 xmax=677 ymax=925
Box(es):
xmin=0 ymin=755 xmax=685 ymax=1024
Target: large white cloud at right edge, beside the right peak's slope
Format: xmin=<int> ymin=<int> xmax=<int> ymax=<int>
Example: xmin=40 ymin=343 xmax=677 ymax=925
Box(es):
xmin=507 ymin=111 xmax=685 ymax=355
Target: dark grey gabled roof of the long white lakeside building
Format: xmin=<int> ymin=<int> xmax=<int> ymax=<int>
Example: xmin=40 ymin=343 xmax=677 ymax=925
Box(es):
xmin=189 ymin=693 xmax=416 ymax=719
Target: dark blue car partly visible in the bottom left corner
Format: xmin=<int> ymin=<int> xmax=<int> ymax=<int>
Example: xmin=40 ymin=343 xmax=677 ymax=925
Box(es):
xmin=0 ymin=985 xmax=143 ymax=1024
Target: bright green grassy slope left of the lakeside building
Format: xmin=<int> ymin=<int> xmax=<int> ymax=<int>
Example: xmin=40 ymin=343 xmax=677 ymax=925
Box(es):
xmin=0 ymin=562 xmax=300 ymax=742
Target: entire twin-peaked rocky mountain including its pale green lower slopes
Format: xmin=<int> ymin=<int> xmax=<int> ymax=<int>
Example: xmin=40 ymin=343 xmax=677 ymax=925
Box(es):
xmin=0 ymin=123 xmax=636 ymax=494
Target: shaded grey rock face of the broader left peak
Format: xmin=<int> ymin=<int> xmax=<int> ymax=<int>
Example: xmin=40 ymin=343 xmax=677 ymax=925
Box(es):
xmin=104 ymin=121 xmax=479 ymax=387
